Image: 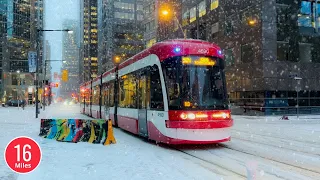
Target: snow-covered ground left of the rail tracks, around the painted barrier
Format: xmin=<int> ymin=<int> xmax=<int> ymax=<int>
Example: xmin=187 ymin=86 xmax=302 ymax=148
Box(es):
xmin=0 ymin=106 xmax=225 ymax=180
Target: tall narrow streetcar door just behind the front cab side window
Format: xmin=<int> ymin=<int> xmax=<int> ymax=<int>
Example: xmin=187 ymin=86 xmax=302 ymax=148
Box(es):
xmin=137 ymin=71 xmax=150 ymax=137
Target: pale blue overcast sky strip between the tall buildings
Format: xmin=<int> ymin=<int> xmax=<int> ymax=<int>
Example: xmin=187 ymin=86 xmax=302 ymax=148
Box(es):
xmin=44 ymin=0 xmax=82 ymax=80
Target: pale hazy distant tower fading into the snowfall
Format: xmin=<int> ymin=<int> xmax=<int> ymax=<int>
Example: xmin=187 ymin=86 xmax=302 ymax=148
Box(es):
xmin=60 ymin=20 xmax=80 ymax=98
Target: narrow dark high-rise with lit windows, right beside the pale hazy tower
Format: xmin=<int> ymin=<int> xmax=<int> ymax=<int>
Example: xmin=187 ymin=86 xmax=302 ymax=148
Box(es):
xmin=80 ymin=0 xmax=98 ymax=82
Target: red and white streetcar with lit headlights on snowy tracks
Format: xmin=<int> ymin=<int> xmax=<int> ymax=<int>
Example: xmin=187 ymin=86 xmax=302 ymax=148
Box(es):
xmin=80 ymin=39 xmax=233 ymax=144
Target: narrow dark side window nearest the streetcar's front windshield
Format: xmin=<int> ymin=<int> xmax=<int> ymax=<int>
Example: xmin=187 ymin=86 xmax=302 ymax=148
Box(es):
xmin=150 ymin=65 xmax=164 ymax=110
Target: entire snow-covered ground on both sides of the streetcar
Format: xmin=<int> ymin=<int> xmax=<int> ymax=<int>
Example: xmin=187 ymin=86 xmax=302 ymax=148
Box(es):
xmin=0 ymin=105 xmax=320 ymax=180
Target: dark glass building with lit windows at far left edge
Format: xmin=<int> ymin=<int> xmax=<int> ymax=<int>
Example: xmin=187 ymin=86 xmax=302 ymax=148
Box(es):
xmin=0 ymin=0 xmax=43 ymax=102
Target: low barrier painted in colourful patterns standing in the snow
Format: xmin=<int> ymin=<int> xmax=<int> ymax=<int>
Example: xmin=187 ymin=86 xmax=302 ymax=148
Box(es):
xmin=39 ymin=119 xmax=116 ymax=145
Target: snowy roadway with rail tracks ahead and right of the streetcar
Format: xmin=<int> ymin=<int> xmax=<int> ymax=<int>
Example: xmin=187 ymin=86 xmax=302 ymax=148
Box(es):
xmin=175 ymin=116 xmax=320 ymax=179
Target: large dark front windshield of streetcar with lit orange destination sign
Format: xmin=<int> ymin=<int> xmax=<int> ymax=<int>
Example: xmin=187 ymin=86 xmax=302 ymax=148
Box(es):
xmin=162 ymin=56 xmax=228 ymax=110
